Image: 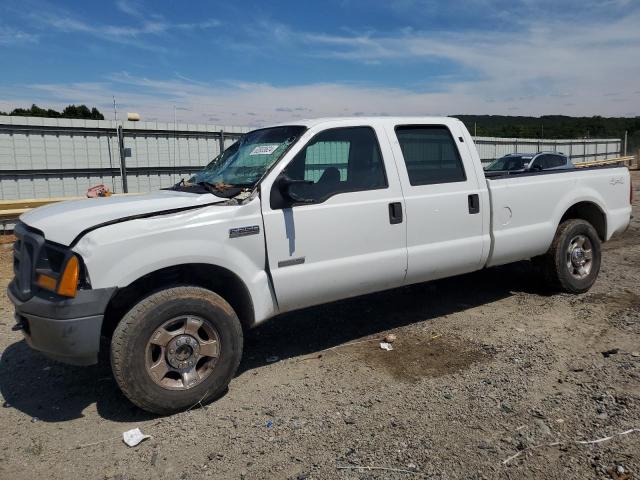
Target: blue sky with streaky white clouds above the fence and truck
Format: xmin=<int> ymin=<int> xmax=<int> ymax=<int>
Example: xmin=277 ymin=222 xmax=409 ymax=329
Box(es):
xmin=0 ymin=0 xmax=640 ymax=125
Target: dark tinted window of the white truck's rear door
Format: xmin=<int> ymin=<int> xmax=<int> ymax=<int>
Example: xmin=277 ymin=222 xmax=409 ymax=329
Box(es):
xmin=396 ymin=125 xmax=467 ymax=186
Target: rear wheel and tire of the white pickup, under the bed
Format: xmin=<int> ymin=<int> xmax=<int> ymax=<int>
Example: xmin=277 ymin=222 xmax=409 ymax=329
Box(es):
xmin=536 ymin=219 xmax=602 ymax=293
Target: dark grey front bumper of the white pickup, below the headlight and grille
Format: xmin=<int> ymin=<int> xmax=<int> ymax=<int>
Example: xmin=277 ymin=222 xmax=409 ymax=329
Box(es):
xmin=7 ymin=282 xmax=116 ymax=365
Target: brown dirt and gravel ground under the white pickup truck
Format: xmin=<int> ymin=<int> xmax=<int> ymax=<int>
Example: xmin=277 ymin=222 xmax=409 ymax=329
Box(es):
xmin=0 ymin=172 xmax=640 ymax=480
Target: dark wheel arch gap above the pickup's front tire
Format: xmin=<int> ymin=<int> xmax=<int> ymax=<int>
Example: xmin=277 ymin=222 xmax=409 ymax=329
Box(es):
xmin=102 ymin=263 xmax=255 ymax=338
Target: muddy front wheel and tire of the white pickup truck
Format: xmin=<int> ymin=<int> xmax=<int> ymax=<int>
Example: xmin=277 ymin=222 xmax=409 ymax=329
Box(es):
xmin=111 ymin=286 xmax=243 ymax=415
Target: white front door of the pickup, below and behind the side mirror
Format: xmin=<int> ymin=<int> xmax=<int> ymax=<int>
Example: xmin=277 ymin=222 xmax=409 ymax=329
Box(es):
xmin=262 ymin=126 xmax=407 ymax=312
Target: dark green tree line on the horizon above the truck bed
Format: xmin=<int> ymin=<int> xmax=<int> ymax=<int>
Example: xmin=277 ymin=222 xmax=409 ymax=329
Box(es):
xmin=453 ymin=115 xmax=640 ymax=153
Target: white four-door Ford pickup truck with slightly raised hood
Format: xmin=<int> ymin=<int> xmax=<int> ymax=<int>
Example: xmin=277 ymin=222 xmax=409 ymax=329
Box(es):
xmin=8 ymin=117 xmax=632 ymax=413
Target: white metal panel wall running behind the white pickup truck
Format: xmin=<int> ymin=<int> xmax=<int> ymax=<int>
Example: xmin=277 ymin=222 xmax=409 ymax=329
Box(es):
xmin=0 ymin=116 xmax=621 ymax=200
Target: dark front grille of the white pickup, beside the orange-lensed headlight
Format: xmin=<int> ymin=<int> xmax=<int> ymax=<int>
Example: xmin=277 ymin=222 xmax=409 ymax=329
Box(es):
xmin=13 ymin=223 xmax=44 ymax=301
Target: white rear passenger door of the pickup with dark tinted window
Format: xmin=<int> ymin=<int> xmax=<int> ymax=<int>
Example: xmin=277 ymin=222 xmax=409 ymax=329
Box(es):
xmin=388 ymin=122 xmax=490 ymax=283
